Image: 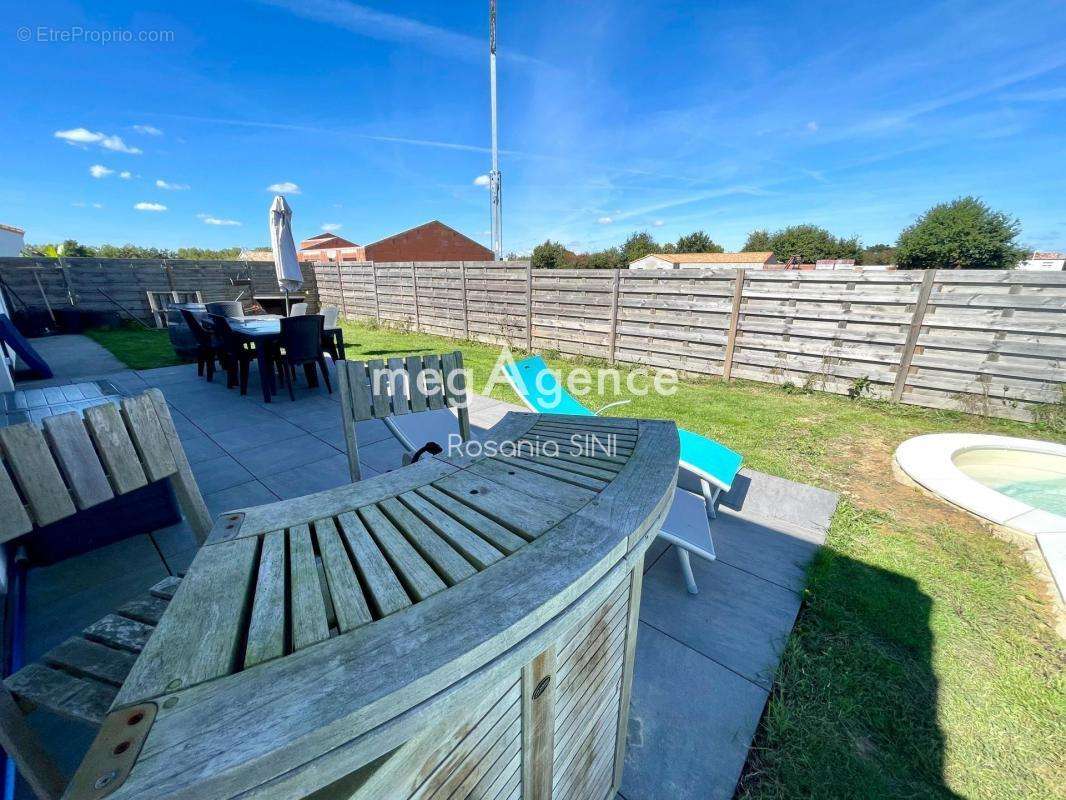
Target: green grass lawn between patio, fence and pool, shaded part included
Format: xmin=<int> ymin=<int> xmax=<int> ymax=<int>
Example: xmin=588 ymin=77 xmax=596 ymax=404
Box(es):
xmin=94 ymin=323 xmax=1066 ymax=800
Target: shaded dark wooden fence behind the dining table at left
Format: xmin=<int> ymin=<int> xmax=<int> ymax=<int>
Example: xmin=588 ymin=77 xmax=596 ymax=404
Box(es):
xmin=0 ymin=258 xmax=314 ymax=321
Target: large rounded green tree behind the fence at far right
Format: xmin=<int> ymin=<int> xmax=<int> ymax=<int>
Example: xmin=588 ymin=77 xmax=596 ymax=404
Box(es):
xmin=895 ymin=197 xmax=1025 ymax=270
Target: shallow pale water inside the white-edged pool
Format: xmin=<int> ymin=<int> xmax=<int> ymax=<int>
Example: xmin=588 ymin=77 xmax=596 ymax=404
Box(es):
xmin=953 ymin=447 xmax=1066 ymax=517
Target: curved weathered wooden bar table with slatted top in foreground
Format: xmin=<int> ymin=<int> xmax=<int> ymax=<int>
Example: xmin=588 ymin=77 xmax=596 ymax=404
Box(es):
xmin=66 ymin=413 xmax=678 ymax=800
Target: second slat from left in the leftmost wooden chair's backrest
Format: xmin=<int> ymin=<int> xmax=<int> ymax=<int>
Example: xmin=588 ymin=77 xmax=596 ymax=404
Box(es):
xmin=0 ymin=422 xmax=77 ymax=525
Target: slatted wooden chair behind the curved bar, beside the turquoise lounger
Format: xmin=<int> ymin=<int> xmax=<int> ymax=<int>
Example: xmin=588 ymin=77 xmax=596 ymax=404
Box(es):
xmin=337 ymin=351 xmax=470 ymax=482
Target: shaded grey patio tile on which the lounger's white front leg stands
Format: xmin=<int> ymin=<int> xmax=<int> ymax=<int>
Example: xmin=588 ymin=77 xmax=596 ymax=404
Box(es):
xmin=641 ymin=547 xmax=800 ymax=689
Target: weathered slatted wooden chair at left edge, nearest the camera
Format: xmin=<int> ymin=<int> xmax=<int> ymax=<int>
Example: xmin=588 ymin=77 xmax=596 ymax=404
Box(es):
xmin=0 ymin=389 xmax=211 ymax=800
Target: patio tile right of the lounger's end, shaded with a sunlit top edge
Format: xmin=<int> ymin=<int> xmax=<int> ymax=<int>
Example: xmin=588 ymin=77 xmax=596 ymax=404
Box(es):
xmin=711 ymin=508 xmax=824 ymax=592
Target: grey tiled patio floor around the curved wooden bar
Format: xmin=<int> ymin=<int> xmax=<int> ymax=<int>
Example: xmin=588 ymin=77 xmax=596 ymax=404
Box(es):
xmin=12 ymin=366 xmax=836 ymax=800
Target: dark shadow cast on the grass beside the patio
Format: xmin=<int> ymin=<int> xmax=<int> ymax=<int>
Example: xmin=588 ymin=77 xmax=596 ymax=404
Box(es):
xmin=736 ymin=535 xmax=960 ymax=800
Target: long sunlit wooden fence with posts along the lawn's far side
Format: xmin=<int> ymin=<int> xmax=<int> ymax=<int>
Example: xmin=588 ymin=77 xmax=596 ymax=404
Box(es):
xmin=314 ymin=261 xmax=1066 ymax=419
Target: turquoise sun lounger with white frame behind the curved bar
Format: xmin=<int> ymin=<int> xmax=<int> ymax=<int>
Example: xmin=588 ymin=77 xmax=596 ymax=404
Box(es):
xmin=505 ymin=355 xmax=743 ymax=594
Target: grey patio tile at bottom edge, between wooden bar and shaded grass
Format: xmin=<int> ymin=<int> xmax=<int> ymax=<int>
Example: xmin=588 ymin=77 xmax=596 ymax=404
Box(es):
xmin=621 ymin=627 xmax=768 ymax=800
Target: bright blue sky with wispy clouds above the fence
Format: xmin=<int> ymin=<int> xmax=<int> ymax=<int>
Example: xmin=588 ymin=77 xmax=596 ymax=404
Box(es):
xmin=0 ymin=0 xmax=1066 ymax=252
